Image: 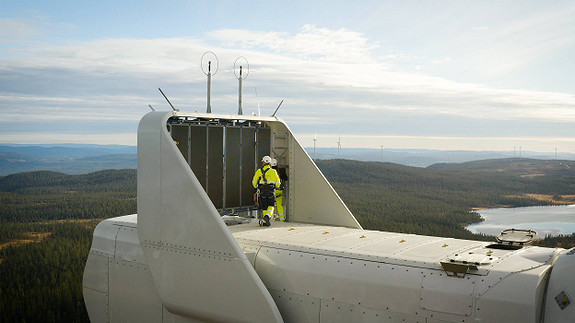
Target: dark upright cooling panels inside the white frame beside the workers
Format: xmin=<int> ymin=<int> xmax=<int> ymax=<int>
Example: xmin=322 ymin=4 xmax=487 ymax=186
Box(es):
xmin=168 ymin=117 xmax=271 ymax=210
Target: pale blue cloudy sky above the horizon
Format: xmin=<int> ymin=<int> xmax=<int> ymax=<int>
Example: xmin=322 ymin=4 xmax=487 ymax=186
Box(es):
xmin=0 ymin=0 xmax=575 ymax=153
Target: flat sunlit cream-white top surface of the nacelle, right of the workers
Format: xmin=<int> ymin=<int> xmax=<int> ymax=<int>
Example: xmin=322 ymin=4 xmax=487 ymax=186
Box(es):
xmin=229 ymin=222 xmax=556 ymax=275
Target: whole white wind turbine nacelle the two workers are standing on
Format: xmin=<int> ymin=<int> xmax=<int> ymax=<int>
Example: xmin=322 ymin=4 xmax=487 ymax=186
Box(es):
xmin=83 ymin=111 xmax=575 ymax=323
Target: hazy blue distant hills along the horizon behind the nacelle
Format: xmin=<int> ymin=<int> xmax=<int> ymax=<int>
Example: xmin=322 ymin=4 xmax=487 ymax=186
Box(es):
xmin=0 ymin=143 xmax=575 ymax=175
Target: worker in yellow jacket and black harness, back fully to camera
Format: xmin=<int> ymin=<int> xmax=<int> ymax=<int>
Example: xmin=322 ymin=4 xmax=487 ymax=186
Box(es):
xmin=252 ymin=156 xmax=280 ymax=227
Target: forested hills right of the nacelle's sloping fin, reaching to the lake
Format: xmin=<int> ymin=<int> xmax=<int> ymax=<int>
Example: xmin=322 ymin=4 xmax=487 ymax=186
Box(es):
xmin=317 ymin=160 xmax=575 ymax=238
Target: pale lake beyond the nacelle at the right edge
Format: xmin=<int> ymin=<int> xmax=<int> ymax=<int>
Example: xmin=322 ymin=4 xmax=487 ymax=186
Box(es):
xmin=467 ymin=205 xmax=575 ymax=238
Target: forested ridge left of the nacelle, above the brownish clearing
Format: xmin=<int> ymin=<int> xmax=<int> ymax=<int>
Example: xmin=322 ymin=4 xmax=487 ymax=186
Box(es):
xmin=0 ymin=169 xmax=136 ymax=222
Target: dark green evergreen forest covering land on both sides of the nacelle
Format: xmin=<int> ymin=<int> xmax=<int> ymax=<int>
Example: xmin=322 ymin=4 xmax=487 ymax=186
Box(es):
xmin=0 ymin=158 xmax=575 ymax=322
